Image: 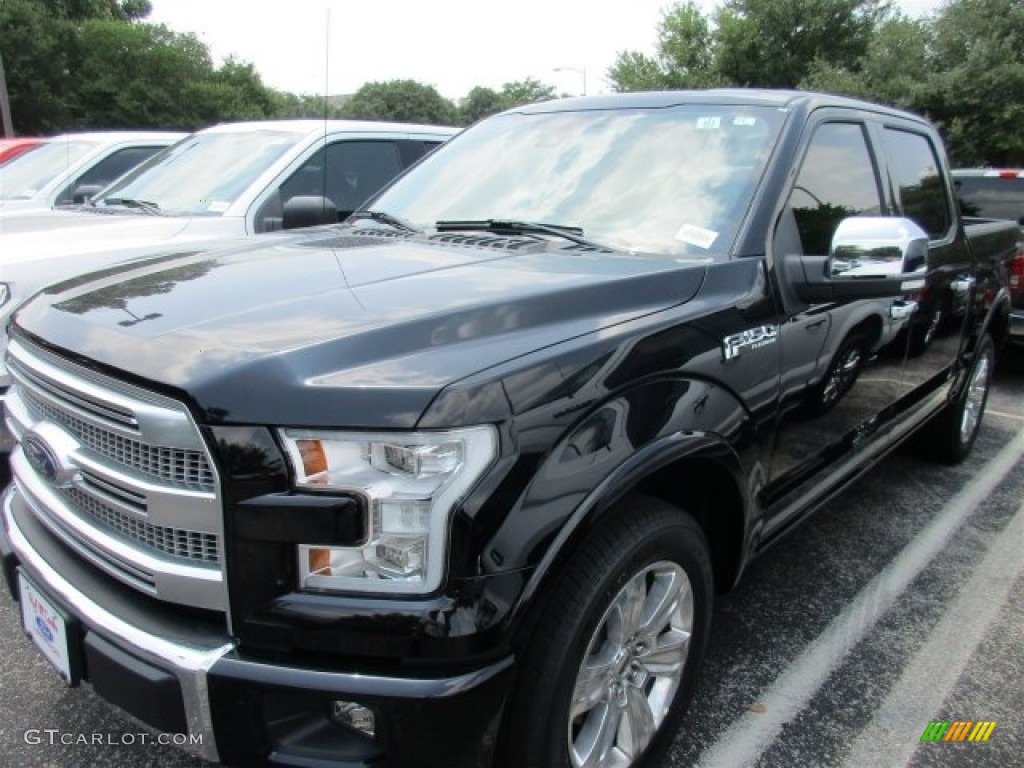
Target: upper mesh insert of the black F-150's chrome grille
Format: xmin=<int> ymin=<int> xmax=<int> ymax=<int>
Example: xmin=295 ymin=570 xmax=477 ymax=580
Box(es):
xmin=18 ymin=367 xmax=213 ymax=490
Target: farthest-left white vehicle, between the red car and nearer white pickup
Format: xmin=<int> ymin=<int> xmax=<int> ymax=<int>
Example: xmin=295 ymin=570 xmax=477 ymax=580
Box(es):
xmin=0 ymin=131 xmax=187 ymax=210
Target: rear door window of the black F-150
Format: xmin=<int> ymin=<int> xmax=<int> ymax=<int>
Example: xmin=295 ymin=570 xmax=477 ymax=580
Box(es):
xmin=884 ymin=128 xmax=952 ymax=240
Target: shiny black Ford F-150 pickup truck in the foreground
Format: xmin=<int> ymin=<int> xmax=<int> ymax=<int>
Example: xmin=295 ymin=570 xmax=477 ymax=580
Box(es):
xmin=0 ymin=90 xmax=1017 ymax=768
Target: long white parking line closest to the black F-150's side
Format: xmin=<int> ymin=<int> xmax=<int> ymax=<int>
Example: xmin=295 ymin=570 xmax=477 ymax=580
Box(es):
xmin=698 ymin=431 xmax=1024 ymax=768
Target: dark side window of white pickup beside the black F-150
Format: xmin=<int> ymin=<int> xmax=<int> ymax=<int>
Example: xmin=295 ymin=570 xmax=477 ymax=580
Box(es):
xmin=256 ymin=140 xmax=402 ymax=232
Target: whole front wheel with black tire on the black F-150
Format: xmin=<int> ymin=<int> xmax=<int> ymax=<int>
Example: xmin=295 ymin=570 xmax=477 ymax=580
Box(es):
xmin=498 ymin=495 xmax=713 ymax=768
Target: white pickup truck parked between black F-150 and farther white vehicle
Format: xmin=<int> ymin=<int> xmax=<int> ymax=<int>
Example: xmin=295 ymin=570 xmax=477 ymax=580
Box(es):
xmin=0 ymin=120 xmax=458 ymax=415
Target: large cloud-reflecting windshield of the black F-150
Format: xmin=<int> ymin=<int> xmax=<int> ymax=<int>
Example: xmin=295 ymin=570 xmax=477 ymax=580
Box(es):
xmin=373 ymin=104 xmax=783 ymax=256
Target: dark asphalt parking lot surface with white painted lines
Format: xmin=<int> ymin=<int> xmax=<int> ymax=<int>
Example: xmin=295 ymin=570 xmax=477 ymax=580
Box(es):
xmin=0 ymin=349 xmax=1024 ymax=768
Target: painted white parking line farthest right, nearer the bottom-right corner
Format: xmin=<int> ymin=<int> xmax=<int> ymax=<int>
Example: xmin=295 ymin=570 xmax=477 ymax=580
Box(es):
xmin=844 ymin=495 xmax=1024 ymax=768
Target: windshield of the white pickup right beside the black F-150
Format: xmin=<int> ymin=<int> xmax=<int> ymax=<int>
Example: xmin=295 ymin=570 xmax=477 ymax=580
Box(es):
xmin=93 ymin=130 xmax=302 ymax=216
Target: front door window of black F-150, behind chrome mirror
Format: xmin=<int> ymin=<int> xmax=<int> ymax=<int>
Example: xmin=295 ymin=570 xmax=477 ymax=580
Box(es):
xmin=784 ymin=123 xmax=883 ymax=255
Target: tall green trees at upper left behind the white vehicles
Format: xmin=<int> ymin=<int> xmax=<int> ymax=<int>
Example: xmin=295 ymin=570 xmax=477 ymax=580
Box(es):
xmin=0 ymin=0 xmax=276 ymax=133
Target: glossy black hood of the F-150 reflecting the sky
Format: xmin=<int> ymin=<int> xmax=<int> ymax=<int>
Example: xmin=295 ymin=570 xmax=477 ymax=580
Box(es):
xmin=14 ymin=227 xmax=707 ymax=428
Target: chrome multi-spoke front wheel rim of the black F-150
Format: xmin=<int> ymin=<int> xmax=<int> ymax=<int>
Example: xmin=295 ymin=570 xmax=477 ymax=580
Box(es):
xmin=568 ymin=561 xmax=693 ymax=768
